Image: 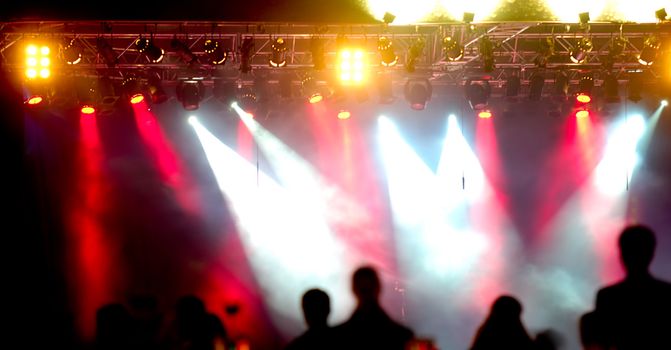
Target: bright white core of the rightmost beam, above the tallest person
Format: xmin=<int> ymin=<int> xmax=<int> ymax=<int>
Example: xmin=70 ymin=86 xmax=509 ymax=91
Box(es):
xmin=594 ymin=115 xmax=646 ymax=195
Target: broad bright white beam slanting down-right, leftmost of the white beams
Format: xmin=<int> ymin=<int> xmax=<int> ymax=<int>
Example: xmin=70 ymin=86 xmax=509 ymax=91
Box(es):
xmin=192 ymin=120 xmax=352 ymax=333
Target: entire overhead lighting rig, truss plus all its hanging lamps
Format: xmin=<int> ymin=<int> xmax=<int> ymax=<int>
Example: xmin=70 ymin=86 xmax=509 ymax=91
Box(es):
xmin=0 ymin=10 xmax=671 ymax=111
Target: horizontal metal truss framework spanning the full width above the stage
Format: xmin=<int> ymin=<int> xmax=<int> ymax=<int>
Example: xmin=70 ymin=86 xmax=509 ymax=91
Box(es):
xmin=0 ymin=20 xmax=671 ymax=97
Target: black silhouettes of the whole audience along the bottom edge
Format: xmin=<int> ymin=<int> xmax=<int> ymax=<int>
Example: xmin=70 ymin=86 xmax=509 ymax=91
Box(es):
xmin=95 ymin=225 xmax=671 ymax=350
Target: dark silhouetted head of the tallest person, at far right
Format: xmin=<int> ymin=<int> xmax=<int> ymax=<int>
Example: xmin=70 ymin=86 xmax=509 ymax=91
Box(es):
xmin=619 ymin=225 xmax=656 ymax=276
